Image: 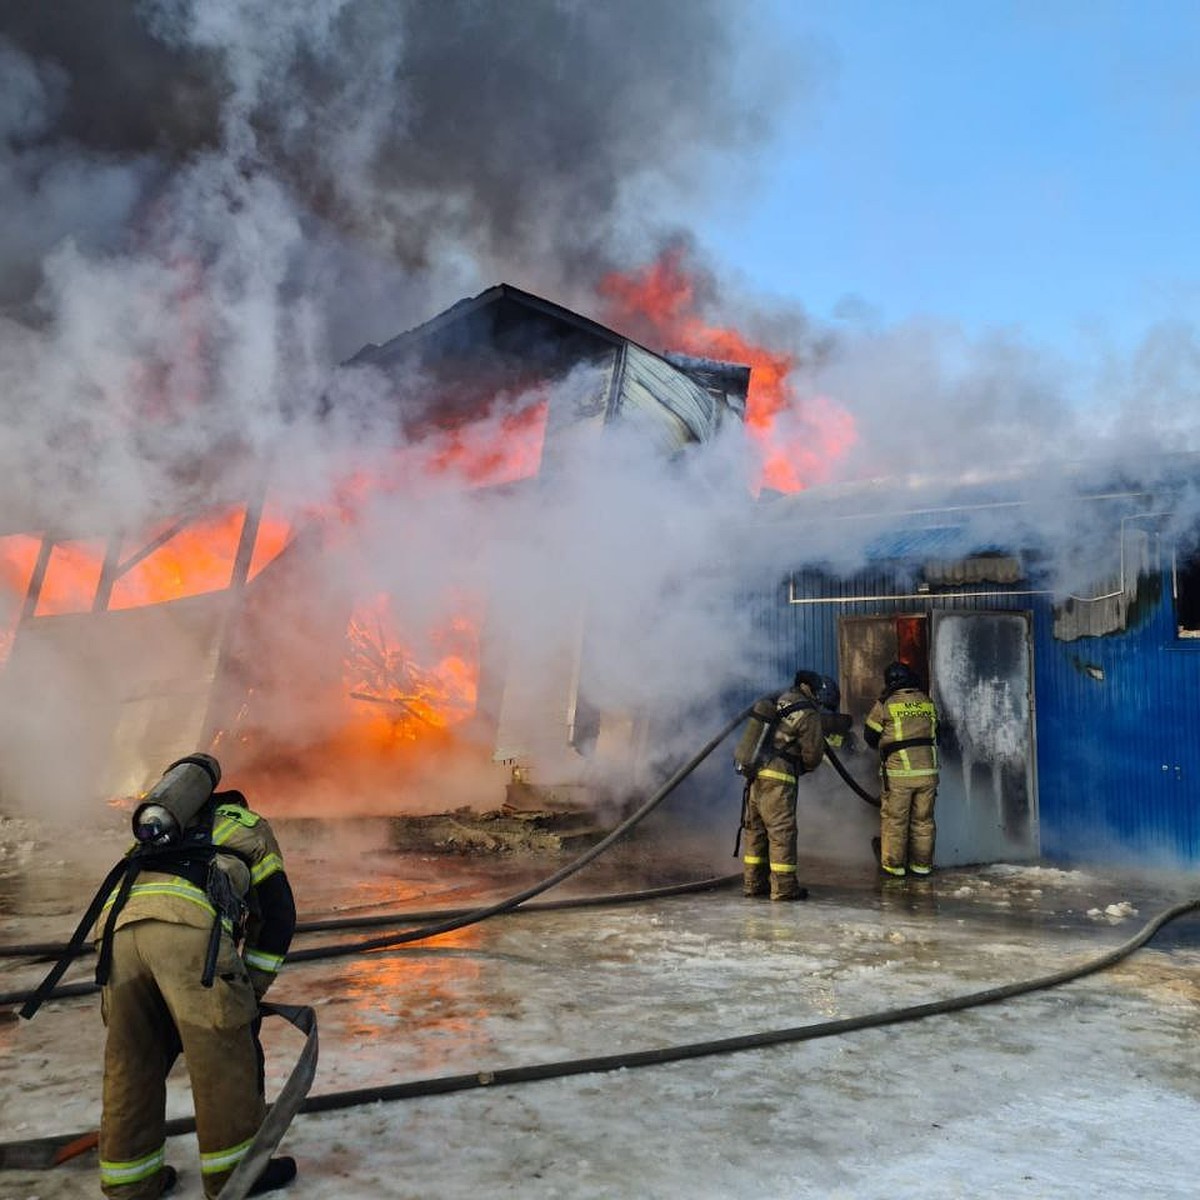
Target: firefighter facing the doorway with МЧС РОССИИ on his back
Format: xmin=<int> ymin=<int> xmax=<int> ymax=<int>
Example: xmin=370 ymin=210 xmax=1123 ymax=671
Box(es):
xmin=863 ymin=662 xmax=937 ymax=876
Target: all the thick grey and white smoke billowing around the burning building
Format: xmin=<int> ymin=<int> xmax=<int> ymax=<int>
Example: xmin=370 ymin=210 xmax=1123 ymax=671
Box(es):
xmin=0 ymin=0 xmax=1198 ymax=854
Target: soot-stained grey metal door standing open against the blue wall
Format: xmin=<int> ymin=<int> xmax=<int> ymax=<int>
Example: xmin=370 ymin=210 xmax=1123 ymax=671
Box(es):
xmin=930 ymin=612 xmax=1040 ymax=866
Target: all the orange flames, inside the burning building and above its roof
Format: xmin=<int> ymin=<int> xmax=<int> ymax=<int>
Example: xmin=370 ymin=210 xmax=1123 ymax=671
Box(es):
xmin=0 ymin=262 xmax=840 ymax=801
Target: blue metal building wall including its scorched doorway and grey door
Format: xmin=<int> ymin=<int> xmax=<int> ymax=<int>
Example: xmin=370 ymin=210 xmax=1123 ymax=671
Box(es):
xmin=737 ymin=487 xmax=1200 ymax=868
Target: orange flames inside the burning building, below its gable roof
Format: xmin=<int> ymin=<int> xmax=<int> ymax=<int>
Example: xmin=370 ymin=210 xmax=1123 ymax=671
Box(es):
xmin=0 ymin=388 xmax=548 ymax=787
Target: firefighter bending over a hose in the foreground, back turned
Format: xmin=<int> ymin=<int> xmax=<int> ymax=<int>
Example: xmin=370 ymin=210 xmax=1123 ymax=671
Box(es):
xmin=94 ymin=755 xmax=296 ymax=1200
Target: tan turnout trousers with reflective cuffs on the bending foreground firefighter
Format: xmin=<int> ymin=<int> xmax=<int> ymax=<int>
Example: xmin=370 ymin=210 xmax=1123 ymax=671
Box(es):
xmin=100 ymin=920 xmax=266 ymax=1200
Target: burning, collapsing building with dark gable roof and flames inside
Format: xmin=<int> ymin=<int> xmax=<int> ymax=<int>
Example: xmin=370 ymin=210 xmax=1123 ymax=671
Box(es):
xmin=0 ymin=284 xmax=750 ymax=811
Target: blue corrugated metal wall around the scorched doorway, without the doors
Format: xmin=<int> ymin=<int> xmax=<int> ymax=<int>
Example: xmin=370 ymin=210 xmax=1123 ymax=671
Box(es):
xmin=757 ymin=571 xmax=1200 ymax=866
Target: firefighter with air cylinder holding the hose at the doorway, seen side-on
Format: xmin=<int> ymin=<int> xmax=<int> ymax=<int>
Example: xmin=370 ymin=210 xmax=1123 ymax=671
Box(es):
xmin=742 ymin=671 xmax=824 ymax=900
